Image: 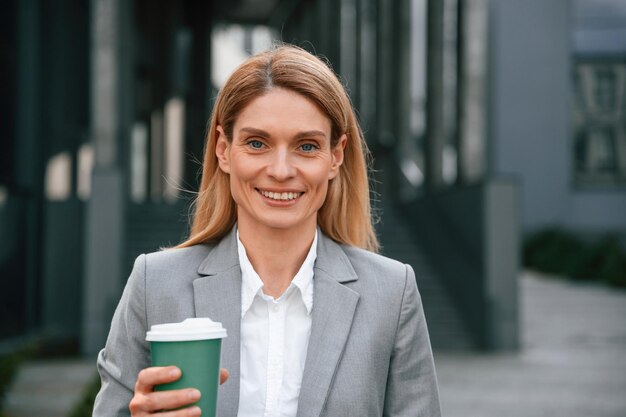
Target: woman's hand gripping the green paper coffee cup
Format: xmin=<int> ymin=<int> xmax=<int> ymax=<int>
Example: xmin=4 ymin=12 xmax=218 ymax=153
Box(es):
xmin=128 ymin=366 xmax=228 ymax=417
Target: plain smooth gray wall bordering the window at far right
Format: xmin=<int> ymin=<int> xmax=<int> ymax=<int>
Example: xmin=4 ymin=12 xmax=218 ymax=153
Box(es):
xmin=489 ymin=0 xmax=626 ymax=232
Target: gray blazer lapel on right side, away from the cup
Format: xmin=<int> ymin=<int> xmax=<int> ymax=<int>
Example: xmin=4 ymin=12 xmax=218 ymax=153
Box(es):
xmin=296 ymin=232 xmax=359 ymax=417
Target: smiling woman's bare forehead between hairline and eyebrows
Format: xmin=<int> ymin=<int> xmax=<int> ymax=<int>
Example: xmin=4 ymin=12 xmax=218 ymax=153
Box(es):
xmin=234 ymin=88 xmax=331 ymax=137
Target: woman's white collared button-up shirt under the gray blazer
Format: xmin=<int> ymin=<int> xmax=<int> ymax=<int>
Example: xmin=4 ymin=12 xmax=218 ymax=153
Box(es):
xmin=237 ymin=231 xmax=317 ymax=417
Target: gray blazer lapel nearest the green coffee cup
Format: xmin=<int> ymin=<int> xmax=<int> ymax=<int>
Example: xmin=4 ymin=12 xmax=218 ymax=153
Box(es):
xmin=193 ymin=228 xmax=241 ymax=416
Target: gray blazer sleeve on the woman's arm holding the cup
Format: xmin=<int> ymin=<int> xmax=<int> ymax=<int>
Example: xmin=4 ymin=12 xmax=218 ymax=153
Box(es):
xmin=93 ymin=255 xmax=150 ymax=417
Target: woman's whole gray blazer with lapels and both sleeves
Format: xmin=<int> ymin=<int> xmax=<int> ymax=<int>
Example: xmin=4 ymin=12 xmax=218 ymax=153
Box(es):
xmin=93 ymin=230 xmax=441 ymax=417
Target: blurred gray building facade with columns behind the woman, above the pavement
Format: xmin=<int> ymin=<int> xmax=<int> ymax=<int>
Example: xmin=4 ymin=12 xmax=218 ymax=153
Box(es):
xmin=0 ymin=0 xmax=626 ymax=354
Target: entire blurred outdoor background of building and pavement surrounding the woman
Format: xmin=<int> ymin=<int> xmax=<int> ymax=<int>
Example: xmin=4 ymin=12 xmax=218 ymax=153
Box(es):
xmin=0 ymin=0 xmax=626 ymax=417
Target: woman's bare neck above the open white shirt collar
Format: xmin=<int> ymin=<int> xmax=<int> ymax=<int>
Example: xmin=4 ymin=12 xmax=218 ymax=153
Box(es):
xmin=237 ymin=222 xmax=317 ymax=298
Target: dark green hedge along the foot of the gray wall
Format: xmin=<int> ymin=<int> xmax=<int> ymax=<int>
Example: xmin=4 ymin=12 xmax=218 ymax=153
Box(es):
xmin=523 ymin=228 xmax=626 ymax=288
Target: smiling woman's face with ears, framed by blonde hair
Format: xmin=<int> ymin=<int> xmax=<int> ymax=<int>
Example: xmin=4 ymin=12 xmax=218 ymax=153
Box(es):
xmin=216 ymin=88 xmax=346 ymax=232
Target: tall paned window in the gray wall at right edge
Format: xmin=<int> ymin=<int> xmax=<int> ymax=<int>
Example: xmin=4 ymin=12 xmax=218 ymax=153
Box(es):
xmin=571 ymin=0 xmax=626 ymax=187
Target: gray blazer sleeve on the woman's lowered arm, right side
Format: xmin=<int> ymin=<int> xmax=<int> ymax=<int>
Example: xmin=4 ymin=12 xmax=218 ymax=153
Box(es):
xmin=383 ymin=265 xmax=441 ymax=417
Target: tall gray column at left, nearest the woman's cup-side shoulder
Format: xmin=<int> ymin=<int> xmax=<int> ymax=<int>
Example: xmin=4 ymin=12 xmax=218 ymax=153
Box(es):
xmin=81 ymin=0 xmax=129 ymax=354
